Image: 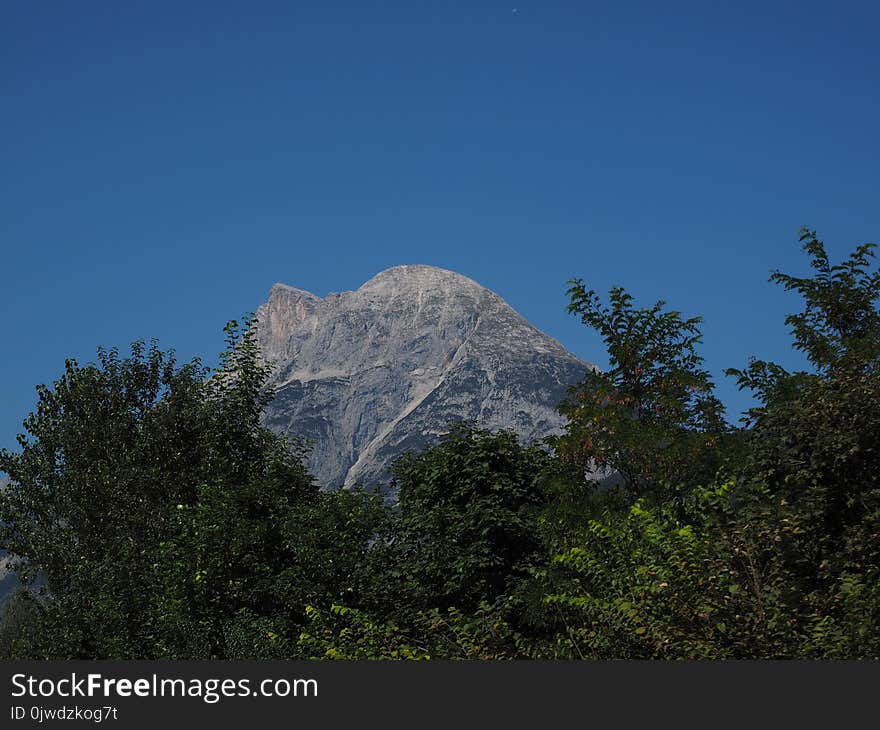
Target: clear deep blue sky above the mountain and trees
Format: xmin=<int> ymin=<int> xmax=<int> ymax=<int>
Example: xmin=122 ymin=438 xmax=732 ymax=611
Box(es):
xmin=0 ymin=0 xmax=880 ymax=447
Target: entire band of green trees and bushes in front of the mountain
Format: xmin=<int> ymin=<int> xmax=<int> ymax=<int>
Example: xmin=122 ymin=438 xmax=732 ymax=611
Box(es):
xmin=0 ymin=231 xmax=880 ymax=659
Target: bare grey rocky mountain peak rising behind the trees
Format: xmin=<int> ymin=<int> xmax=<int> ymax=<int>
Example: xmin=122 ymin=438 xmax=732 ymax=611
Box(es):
xmin=257 ymin=266 xmax=593 ymax=487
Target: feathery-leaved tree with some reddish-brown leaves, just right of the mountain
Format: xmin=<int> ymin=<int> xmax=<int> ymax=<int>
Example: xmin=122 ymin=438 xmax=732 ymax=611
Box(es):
xmin=556 ymin=279 xmax=728 ymax=495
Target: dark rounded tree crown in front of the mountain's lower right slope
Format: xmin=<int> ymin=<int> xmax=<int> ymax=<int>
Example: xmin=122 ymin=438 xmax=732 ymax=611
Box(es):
xmin=394 ymin=425 xmax=549 ymax=609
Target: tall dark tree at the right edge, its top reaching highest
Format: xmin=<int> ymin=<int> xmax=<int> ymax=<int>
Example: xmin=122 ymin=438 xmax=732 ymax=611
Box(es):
xmin=729 ymin=229 xmax=880 ymax=656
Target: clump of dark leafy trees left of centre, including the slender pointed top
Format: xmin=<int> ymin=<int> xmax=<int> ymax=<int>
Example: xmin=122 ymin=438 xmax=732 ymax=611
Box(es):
xmin=0 ymin=319 xmax=383 ymax=659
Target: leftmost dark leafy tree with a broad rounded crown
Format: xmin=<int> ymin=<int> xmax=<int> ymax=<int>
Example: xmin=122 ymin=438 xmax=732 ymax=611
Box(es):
xmin=0 ymin=342 xmax=213 ymax=658
